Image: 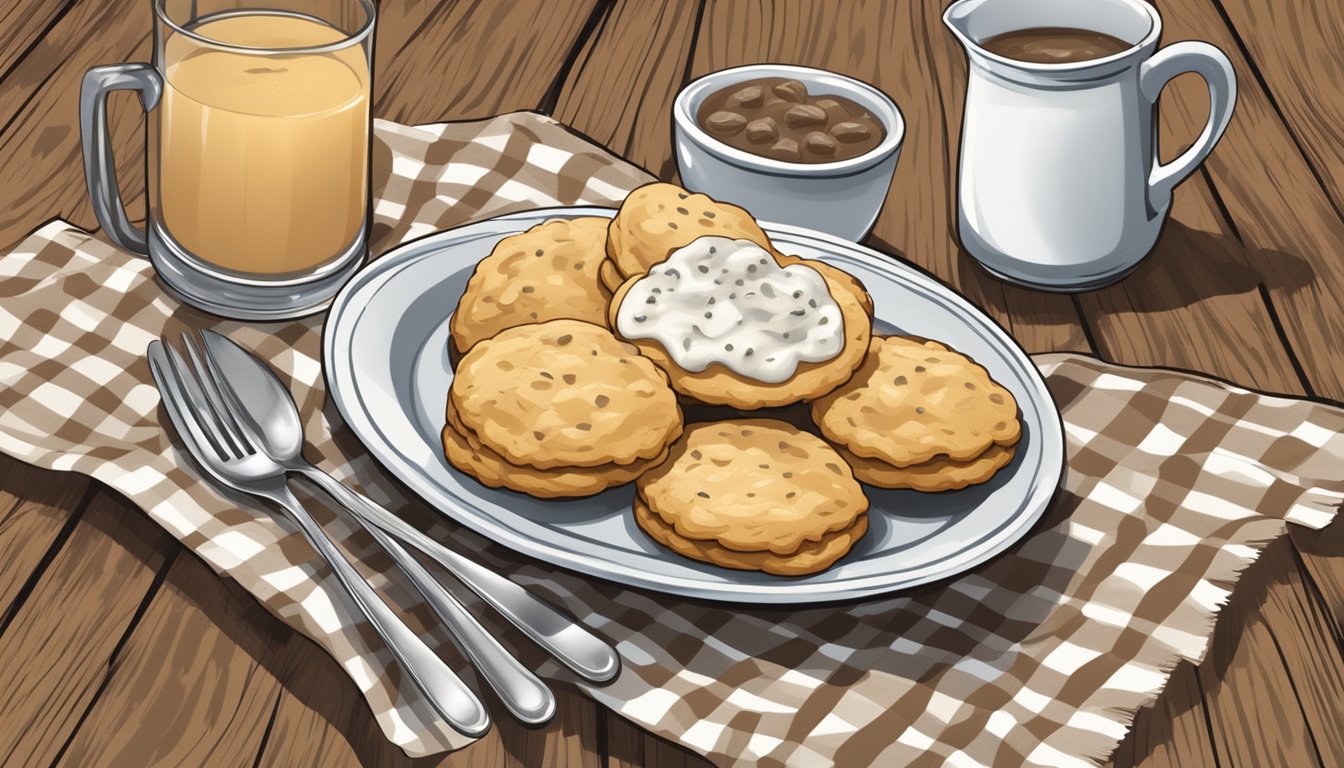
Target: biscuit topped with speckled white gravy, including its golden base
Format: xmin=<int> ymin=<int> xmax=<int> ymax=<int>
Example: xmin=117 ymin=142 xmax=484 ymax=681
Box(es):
xmin=609 ymin=237 xmax=872 ymax=410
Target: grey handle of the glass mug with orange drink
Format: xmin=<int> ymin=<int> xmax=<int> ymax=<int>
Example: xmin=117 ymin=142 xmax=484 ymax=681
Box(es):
xmin=79 ymin=63 xmax=164 ymax=256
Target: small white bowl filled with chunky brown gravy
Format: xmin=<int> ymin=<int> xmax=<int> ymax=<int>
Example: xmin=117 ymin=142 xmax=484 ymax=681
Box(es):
xmin=672 ymin=65 xmax=905 ymax=241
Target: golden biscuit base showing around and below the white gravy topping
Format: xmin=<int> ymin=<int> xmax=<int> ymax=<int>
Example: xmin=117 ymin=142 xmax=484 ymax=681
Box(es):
xmin=607 ymin=257 xmax=872 ymax=410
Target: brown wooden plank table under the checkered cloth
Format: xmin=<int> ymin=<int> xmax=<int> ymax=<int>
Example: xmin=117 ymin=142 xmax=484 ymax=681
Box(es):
xmin=0 ymin=0 xmax=1344 ymax=767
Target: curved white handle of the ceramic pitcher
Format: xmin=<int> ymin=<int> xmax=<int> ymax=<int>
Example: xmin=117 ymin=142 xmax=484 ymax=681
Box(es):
xmin=1138 ymin=40 xmax=1236 ymax=210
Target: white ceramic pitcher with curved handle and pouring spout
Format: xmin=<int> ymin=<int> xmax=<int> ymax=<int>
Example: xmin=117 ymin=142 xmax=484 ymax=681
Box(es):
xmin=943 ymin=0 xmax=1236 ymax=291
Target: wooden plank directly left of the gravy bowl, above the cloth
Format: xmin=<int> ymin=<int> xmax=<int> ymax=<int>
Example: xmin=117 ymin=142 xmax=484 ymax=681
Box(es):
xmin=554 ymin=0 xmax=707 ymax=179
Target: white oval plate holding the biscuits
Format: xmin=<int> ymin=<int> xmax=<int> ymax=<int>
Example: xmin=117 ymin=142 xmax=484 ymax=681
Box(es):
xmin=323 ymin=207 xmax=1064 ymax=604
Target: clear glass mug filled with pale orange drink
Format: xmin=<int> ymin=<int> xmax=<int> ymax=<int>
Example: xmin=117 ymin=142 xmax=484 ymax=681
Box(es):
xmin=79 ymin=0 xmax=375 ymax=320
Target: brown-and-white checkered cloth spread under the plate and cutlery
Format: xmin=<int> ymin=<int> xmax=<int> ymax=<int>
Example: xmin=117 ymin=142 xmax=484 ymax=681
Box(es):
xmin=0 ymin=113 xmax=1344 ymax=767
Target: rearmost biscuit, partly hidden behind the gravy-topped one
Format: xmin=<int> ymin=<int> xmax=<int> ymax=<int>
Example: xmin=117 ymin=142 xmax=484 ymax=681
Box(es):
xmin=606 ymin=182 xmax=773 ymax=277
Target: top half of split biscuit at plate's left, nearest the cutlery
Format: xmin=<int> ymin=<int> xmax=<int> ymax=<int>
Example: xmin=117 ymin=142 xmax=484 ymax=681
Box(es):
xmin=449 ymin=320 xmax=681 ymax=469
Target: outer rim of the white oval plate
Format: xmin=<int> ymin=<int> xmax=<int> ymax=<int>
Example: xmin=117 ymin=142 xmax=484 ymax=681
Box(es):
xmin=321 ymin=206 xmax=1067 ymax=605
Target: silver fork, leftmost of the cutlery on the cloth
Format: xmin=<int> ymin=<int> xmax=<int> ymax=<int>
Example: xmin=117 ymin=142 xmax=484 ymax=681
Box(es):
xmin=146 ymin=340 xmax=491 ymax=737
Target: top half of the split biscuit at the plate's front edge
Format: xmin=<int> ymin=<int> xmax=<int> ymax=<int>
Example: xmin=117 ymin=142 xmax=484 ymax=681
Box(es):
xmin=636 ymin=418 xmax=868 ymax=557
